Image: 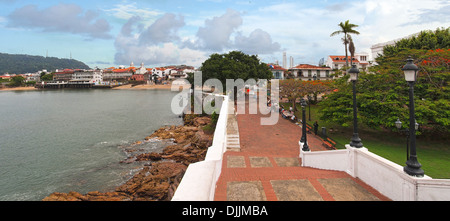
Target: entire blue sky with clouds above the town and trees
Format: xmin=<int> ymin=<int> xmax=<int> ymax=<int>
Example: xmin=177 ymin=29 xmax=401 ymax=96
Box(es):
xmin=0 ymin=0 xmax=450 ymax=68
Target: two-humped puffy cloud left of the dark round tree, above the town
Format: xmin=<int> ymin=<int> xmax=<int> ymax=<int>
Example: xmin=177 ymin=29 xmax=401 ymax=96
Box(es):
xmin=115 ymin=13 xmax=207 ymax=66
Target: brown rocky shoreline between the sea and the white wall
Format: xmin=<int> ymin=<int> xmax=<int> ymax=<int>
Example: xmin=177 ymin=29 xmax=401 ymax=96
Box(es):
xmin=43 ymin=115 xmax=213 ymax=201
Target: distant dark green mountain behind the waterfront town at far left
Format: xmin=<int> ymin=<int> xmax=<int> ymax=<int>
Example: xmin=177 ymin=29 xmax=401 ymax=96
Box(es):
xmin=0 ymin=53 xmax=89 ymax=74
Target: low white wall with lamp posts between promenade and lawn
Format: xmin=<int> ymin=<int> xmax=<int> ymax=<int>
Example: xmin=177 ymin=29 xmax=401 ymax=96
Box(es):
xmin=300 ymin=145 xmax=450 ymax=201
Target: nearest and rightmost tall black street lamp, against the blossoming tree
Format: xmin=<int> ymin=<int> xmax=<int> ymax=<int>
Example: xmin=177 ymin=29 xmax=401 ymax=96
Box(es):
xmin=402 ymin=57 xmax=425 ymax=177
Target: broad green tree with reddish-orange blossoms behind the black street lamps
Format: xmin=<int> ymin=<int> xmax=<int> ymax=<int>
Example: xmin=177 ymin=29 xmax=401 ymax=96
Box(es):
xmin=320 ymin=49 xmax=450 ymax=136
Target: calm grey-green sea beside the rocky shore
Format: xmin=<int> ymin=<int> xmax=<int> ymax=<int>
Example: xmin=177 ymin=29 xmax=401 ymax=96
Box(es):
xmin=0 ymin=89 xmax=182 ymax=201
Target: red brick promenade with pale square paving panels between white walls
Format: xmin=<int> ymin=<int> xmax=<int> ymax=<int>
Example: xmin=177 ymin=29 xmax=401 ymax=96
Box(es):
xmin=215 ymin=99 xmax=389 ymax=201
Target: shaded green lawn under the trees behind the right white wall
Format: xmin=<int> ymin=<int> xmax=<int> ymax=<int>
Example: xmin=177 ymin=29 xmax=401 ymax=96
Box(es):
xmin=282 ymin=103 xmax=450 ymax=179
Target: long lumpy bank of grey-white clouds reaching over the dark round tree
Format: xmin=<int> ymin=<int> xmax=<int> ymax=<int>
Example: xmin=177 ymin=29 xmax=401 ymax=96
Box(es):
xmin=115 ymin=9 xmax=280 ymax=66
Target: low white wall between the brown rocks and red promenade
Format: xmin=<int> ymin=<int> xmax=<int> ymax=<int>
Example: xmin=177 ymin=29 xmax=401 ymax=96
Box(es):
xmin=172 ymin=95 xmax=228 ymax=201
